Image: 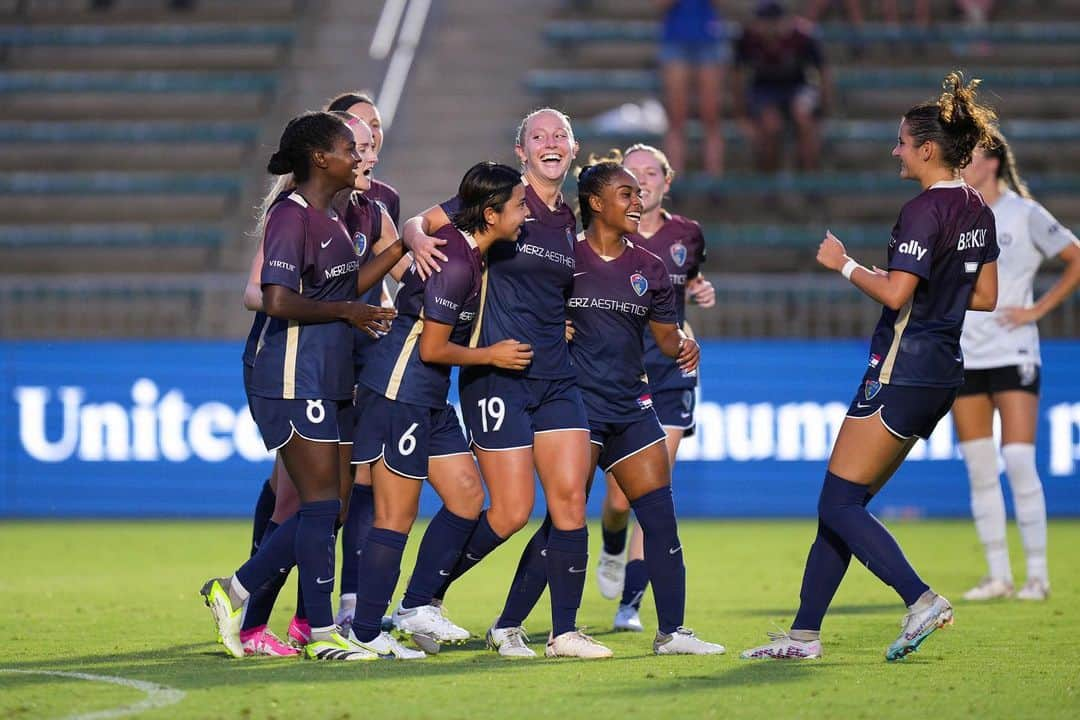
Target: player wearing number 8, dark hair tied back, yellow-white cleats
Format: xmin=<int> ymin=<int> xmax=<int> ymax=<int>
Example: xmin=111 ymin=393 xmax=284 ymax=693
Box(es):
xmin=201 ymin=112 xmax=404 ymax=660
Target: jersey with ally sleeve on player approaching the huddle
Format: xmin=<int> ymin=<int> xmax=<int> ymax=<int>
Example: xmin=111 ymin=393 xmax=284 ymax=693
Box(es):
xmin=869 ymin=180 xmax=998 ymax=388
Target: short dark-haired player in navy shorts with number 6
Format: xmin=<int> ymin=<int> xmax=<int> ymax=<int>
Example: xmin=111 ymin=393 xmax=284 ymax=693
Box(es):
xmin=349 ymin=163 xmax=532 ymax=660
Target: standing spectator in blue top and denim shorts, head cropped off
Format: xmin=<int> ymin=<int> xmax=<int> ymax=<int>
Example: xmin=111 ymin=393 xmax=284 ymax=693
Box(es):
xmin=656 ymin=0 xmax=731 ymax=175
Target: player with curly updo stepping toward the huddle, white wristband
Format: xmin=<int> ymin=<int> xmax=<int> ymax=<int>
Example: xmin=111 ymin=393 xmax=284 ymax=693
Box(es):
xmin=742 ymin=72 xmax=998 ymax=661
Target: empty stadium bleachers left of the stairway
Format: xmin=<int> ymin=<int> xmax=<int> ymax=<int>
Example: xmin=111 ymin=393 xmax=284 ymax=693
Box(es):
xmin=0 ymin=0 xmax=299 ymax=337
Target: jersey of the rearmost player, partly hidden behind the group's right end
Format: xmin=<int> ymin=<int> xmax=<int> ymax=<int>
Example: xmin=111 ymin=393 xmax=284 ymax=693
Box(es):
xmin=630 ymin=212 xmax=705 ymax=393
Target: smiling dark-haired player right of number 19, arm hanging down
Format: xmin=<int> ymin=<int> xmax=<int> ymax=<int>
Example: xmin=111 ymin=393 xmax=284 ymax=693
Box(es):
xmin=567 ymin=160 xmax=724 ymax=655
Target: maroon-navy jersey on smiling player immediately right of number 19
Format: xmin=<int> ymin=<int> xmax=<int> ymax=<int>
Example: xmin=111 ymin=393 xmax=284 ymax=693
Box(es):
xmin=567 ymin=240 xmax=678 ymax=422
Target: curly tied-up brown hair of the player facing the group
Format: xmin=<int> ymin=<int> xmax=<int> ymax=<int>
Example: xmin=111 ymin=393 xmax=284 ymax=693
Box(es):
xmin=904 ymin=71 xmax=997 ymax=169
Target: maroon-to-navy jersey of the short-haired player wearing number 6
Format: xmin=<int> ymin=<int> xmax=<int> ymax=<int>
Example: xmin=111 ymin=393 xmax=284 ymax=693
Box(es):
xmin=359 ymin=225 xmax=484 ymax=408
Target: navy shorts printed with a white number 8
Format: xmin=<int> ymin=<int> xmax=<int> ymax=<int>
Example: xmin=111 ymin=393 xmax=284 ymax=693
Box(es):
xmin=247 ymin=395 xmax=352 ymax=452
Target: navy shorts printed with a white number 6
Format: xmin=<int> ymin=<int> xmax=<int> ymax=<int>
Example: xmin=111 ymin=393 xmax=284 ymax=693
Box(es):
xmin=352 ymin=385 xmax=471 ymax=480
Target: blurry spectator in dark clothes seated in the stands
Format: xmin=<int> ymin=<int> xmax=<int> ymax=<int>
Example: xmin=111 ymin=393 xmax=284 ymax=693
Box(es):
xmin=733 ymin=0 xmax=832 ymax=172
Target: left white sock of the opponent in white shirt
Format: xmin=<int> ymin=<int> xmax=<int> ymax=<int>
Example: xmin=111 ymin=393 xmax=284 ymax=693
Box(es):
xmin=960 ymin=437 xmax=1012 ymax=583
